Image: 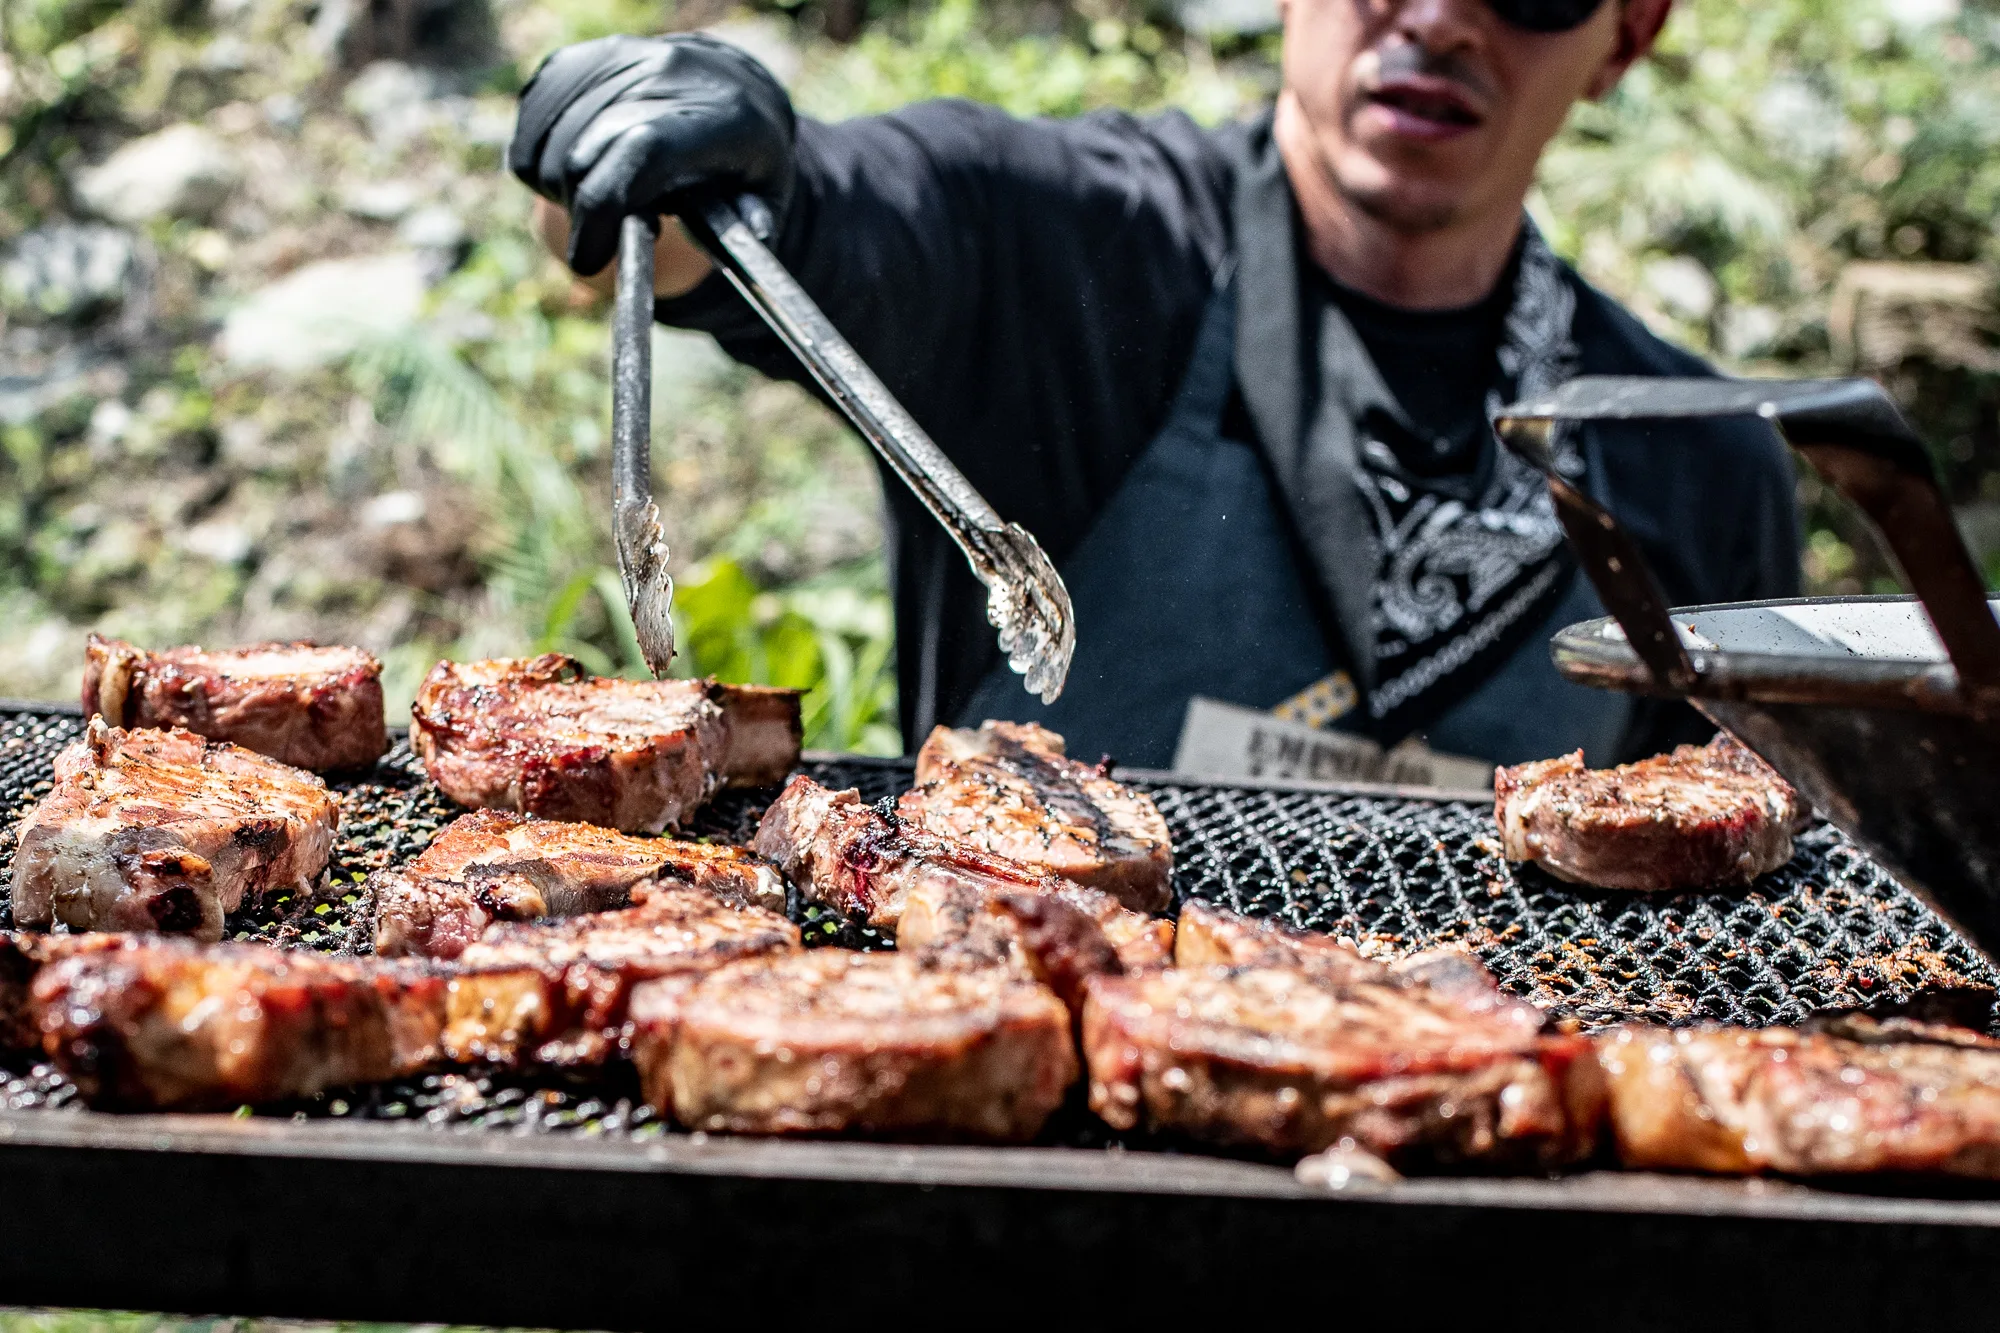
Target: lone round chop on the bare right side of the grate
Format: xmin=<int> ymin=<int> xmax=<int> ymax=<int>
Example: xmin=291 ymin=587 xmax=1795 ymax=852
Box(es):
xmin=1494 ymin=735 xmax=1812 ymax=891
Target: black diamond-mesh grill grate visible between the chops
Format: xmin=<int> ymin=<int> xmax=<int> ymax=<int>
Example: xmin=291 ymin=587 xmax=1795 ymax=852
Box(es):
xmin=0 ymin=696 xmax=1996 ymax=1141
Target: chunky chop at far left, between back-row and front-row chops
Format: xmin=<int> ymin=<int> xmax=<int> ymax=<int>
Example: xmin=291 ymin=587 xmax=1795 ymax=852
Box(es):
xmin=14 ymin=717 xmax=340 ymax=939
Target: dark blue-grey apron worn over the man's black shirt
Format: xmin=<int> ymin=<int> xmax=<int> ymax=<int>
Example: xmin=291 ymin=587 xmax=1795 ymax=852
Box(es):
xmin=956 ymin=278 xmax=1632 ymax=769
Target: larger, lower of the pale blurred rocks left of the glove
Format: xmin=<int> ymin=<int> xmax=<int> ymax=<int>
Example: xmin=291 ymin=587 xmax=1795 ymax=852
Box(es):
xmin=216 ymin=250 xmax=424 ymax=370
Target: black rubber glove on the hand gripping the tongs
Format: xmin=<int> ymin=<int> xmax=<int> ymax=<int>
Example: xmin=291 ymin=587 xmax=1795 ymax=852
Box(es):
xmin=508 ymin=32 xmax=796 ymax=276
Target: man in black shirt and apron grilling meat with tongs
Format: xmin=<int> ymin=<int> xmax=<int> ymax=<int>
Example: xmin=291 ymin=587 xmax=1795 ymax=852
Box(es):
xmin=510 ymin=0 xmax=1798 ymax=767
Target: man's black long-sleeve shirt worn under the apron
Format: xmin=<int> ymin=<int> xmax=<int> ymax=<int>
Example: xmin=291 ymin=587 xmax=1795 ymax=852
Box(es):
xmin=658 ymin=100 xmax=1798 ymax=745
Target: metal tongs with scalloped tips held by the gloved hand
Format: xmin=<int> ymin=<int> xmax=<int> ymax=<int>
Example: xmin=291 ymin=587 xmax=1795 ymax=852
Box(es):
xmin=612 ymin=200 xmax=1076 ymax=703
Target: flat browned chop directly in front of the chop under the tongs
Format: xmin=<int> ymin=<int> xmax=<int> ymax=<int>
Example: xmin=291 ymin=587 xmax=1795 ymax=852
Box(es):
xmin=370 ymin=811 xmax=784 ymax=959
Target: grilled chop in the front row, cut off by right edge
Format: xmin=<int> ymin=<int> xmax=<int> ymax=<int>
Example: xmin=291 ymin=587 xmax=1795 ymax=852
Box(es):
xmin=1598 ymin=1019 xmax=2000 ymax=1179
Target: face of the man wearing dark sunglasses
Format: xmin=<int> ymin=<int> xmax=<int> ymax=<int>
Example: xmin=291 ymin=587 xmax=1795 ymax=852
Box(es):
xmin=1280 ymin=0 xmax=1666 ymax=232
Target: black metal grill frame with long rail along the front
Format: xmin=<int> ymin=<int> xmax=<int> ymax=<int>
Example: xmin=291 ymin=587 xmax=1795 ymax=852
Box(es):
xmin=0 ymin=701 xmax=2000 ymax=1327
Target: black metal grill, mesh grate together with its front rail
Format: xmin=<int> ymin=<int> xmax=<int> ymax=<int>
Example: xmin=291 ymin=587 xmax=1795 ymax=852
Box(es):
xmin=0 ymin=703 xmax=2000 ymax=1327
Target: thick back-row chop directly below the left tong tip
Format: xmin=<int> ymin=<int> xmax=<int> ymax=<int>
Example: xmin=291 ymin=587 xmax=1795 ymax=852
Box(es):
xmin=410 ymin=652 xmax=800 ymax=833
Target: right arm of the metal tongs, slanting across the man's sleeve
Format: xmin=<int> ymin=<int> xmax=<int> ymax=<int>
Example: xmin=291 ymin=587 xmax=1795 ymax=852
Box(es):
xmin=688 ymin=200 xmax=1076 ymax=703
